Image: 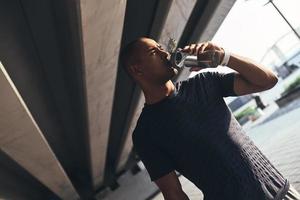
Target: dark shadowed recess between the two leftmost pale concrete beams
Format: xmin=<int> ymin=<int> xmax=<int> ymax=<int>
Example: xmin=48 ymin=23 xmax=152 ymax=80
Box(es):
xmin=0 ymin=0 xmax=91 ymax=194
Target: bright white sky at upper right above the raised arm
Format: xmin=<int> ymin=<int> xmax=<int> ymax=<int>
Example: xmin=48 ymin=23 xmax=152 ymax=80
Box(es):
xmin=212 ymin=0 xmax=300 ymax=61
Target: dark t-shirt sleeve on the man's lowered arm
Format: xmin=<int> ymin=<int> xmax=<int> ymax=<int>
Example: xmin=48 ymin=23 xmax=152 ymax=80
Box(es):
xmin=132 ymin=129 xmax=175 ymax=181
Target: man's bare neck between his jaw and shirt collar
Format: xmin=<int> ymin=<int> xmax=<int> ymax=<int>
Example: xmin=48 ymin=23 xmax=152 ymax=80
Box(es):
xmin=143 ymin=80 xmax=175 ymax=104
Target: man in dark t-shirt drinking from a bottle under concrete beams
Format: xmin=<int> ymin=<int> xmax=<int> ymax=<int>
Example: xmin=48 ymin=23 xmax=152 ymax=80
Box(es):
xmin=121 ymin=38 xmax=300 ymax=200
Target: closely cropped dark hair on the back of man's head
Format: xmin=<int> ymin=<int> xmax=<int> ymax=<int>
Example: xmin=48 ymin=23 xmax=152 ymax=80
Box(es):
xmin=120 ymin=38 xmax=141 ymax=77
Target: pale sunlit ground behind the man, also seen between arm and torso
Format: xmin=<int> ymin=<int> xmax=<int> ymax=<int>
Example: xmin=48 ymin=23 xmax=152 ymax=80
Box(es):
xmin=153 ymin=102 xmax=300 ymax=200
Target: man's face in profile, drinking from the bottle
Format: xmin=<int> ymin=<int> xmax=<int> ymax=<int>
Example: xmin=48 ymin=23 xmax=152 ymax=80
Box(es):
xmin=137 ymin=38 xmax=178 ymax=84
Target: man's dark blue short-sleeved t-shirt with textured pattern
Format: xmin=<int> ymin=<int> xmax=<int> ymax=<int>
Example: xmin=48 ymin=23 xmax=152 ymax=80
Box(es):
xmin=132 ymin=72 xmax=289 ymax=200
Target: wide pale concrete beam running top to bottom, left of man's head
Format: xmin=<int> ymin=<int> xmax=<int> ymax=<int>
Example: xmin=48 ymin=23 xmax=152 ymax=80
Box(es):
xmin=80 ymin=0 xmax=126 ymax=188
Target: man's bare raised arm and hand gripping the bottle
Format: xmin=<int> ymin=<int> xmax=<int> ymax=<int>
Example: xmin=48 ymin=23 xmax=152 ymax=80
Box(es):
xmin=183 ymin=42 xmax=278 ymax=95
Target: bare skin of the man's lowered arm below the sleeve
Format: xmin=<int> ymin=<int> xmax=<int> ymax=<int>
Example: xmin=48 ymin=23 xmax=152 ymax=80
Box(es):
xmin=154 ymin=171 xmax=189 ymax=200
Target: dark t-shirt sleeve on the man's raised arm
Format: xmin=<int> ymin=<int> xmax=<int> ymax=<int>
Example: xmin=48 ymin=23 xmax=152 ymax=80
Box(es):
xmin=194 ymin=71 xmax=237 ymax=97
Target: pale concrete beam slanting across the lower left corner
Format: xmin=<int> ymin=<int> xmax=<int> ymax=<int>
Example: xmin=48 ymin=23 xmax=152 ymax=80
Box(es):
xmin=0 ymin=63 xmax=79 ymax=199
